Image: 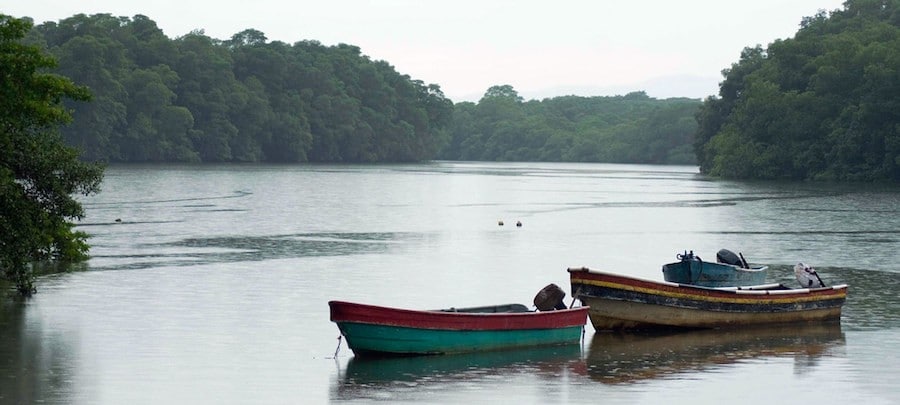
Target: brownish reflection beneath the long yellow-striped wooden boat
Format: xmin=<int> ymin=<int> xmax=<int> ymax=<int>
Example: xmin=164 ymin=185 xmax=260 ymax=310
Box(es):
xmin=587 ymin=322 xmax=844 ymax=384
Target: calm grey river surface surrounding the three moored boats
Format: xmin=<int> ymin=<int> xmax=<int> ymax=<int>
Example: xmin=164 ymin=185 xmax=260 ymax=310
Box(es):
xmin=0 ymin=162 xmax=900 ymax=405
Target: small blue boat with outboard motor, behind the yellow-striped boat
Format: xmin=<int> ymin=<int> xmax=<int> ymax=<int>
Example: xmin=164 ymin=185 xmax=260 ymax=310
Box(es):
xmin=663 ymin=249 xmax=769 ymax=287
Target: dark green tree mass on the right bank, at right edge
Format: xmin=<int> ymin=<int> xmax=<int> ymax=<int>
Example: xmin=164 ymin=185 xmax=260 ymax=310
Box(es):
xmin=695 ymin=0 xmax=900 ymax=181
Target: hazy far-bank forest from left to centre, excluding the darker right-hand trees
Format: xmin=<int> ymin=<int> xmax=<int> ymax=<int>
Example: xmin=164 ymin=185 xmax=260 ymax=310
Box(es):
xmin=19 ymin=14 xmax=700 ymax=164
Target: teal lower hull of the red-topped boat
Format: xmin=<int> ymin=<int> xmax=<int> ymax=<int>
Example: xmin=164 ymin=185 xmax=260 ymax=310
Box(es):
xmin=338 ymin=322 xmax=582 ymax=354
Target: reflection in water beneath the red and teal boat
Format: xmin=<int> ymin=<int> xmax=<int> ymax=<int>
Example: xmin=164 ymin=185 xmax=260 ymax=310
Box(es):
xmin=332 ymin=344 xmax=583 ymax=400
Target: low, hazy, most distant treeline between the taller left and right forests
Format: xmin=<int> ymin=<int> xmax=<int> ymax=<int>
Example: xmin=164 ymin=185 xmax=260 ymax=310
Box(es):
xmin=440 ymin=85 xmax=700 ymax=164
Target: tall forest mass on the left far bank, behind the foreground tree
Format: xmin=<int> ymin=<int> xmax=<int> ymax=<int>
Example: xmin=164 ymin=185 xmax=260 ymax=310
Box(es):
xmin=29 ymin=14 xmax=453 ymax=162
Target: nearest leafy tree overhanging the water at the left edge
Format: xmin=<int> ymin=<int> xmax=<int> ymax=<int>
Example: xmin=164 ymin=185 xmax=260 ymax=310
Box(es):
xmin=0 ymin=14 xmax=103 ymax=295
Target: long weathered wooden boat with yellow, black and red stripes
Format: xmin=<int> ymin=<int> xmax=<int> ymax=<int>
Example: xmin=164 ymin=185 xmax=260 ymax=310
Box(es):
xmin=569 ymin=268 xmax=847 ymax=331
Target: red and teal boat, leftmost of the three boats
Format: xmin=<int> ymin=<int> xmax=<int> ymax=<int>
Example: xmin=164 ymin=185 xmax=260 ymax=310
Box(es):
xmin=328 ymin=286 xmax=588 ymax=355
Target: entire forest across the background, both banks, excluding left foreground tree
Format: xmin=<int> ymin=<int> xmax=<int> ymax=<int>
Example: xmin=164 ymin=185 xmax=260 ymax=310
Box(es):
xmin=10 ymin=0 xmax=900 ymax=181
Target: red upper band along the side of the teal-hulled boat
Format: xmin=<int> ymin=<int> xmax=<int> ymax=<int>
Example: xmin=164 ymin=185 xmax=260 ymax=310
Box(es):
xmin=328 ymin=301 xmax=588 ymax=330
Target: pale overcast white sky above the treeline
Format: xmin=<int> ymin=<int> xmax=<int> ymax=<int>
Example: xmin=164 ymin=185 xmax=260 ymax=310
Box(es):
xmin=8 ymin=0 xmax=843 ymax=102
